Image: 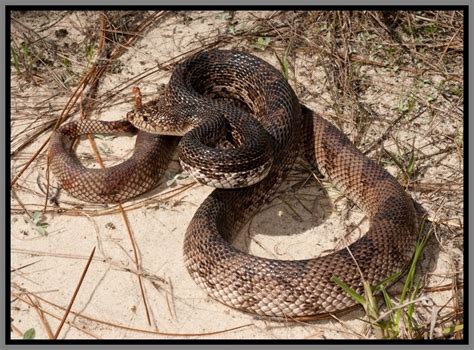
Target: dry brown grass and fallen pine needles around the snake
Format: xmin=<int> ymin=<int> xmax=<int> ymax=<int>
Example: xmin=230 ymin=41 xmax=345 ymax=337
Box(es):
xmin=10 ymin=11 xmax=464 ymax=339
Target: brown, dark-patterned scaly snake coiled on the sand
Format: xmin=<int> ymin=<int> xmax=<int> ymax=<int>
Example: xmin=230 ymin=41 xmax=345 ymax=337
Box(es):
xmin=49 ymin=49 xmax=418 ymax=320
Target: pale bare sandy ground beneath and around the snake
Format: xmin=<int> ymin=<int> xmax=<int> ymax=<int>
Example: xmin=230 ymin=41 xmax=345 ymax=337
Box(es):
xmin=11 ymin=12 xmax=463 ymax=339
